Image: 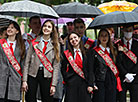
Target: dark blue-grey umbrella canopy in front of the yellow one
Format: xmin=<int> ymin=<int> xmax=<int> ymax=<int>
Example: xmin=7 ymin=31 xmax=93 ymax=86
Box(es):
xmin=88 ymin=11 xmax=138 ymax=29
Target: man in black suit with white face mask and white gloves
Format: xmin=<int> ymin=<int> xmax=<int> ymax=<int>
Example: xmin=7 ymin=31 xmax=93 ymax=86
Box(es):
xmin=116 ymin=25 xmax=138 ymax=102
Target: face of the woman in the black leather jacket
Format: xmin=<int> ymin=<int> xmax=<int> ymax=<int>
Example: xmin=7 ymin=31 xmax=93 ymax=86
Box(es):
xmin=99 ymin=31 xmax=109 ymax=45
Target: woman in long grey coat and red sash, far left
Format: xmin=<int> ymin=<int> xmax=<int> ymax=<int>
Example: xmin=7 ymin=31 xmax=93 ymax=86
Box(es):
xmin=0 ymin=21 xmax=25 ymax=102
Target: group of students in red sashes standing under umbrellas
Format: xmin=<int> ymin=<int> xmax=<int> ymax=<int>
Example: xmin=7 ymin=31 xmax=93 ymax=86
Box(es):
xmin=0 ymin=16 xmax=138 ymax=102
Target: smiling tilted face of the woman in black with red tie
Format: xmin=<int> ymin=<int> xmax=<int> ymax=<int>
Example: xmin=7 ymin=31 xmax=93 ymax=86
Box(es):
xmin=69 ymin=33 xmax=81 ymax=48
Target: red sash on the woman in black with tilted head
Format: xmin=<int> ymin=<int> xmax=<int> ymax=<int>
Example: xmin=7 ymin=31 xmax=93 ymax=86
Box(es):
xmin=64 ymin=50 xmax=85 ymax=79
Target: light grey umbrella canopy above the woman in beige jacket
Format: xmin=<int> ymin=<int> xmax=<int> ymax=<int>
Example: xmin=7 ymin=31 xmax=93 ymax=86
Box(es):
xmin=0 ymin=0 xmax=59 ymax=18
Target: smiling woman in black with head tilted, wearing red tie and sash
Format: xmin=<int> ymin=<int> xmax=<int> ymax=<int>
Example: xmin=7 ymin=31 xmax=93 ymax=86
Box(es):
xmin=61 ymin=32 xmax=91 ymax=102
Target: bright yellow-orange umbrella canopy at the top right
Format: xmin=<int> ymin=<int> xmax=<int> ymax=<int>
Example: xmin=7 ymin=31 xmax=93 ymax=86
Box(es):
xmin=98 ymin=1 xmax=138 ymax=14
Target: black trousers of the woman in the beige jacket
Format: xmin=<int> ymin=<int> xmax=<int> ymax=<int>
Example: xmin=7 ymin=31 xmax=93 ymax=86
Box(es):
xmin=25 ymin=70 xmax=53 ymax=102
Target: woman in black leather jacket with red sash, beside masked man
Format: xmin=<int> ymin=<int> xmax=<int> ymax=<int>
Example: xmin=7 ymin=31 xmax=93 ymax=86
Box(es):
xmin=87 ymin=29 xmax=121 ymax=102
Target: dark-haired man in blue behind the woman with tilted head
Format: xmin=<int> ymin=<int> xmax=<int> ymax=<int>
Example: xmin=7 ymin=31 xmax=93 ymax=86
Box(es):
xmin=73 ymin=18 xmax=96 ymax=49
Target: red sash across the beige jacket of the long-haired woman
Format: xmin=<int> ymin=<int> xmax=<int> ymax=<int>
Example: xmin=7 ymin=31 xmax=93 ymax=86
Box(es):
xmin=32 ymin=38 xmax=53 ymax=73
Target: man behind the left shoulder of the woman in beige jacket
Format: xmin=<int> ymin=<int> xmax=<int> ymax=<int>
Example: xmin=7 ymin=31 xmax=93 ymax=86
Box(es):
xmin=23 ymin=16 xmax=41 ymax=50
